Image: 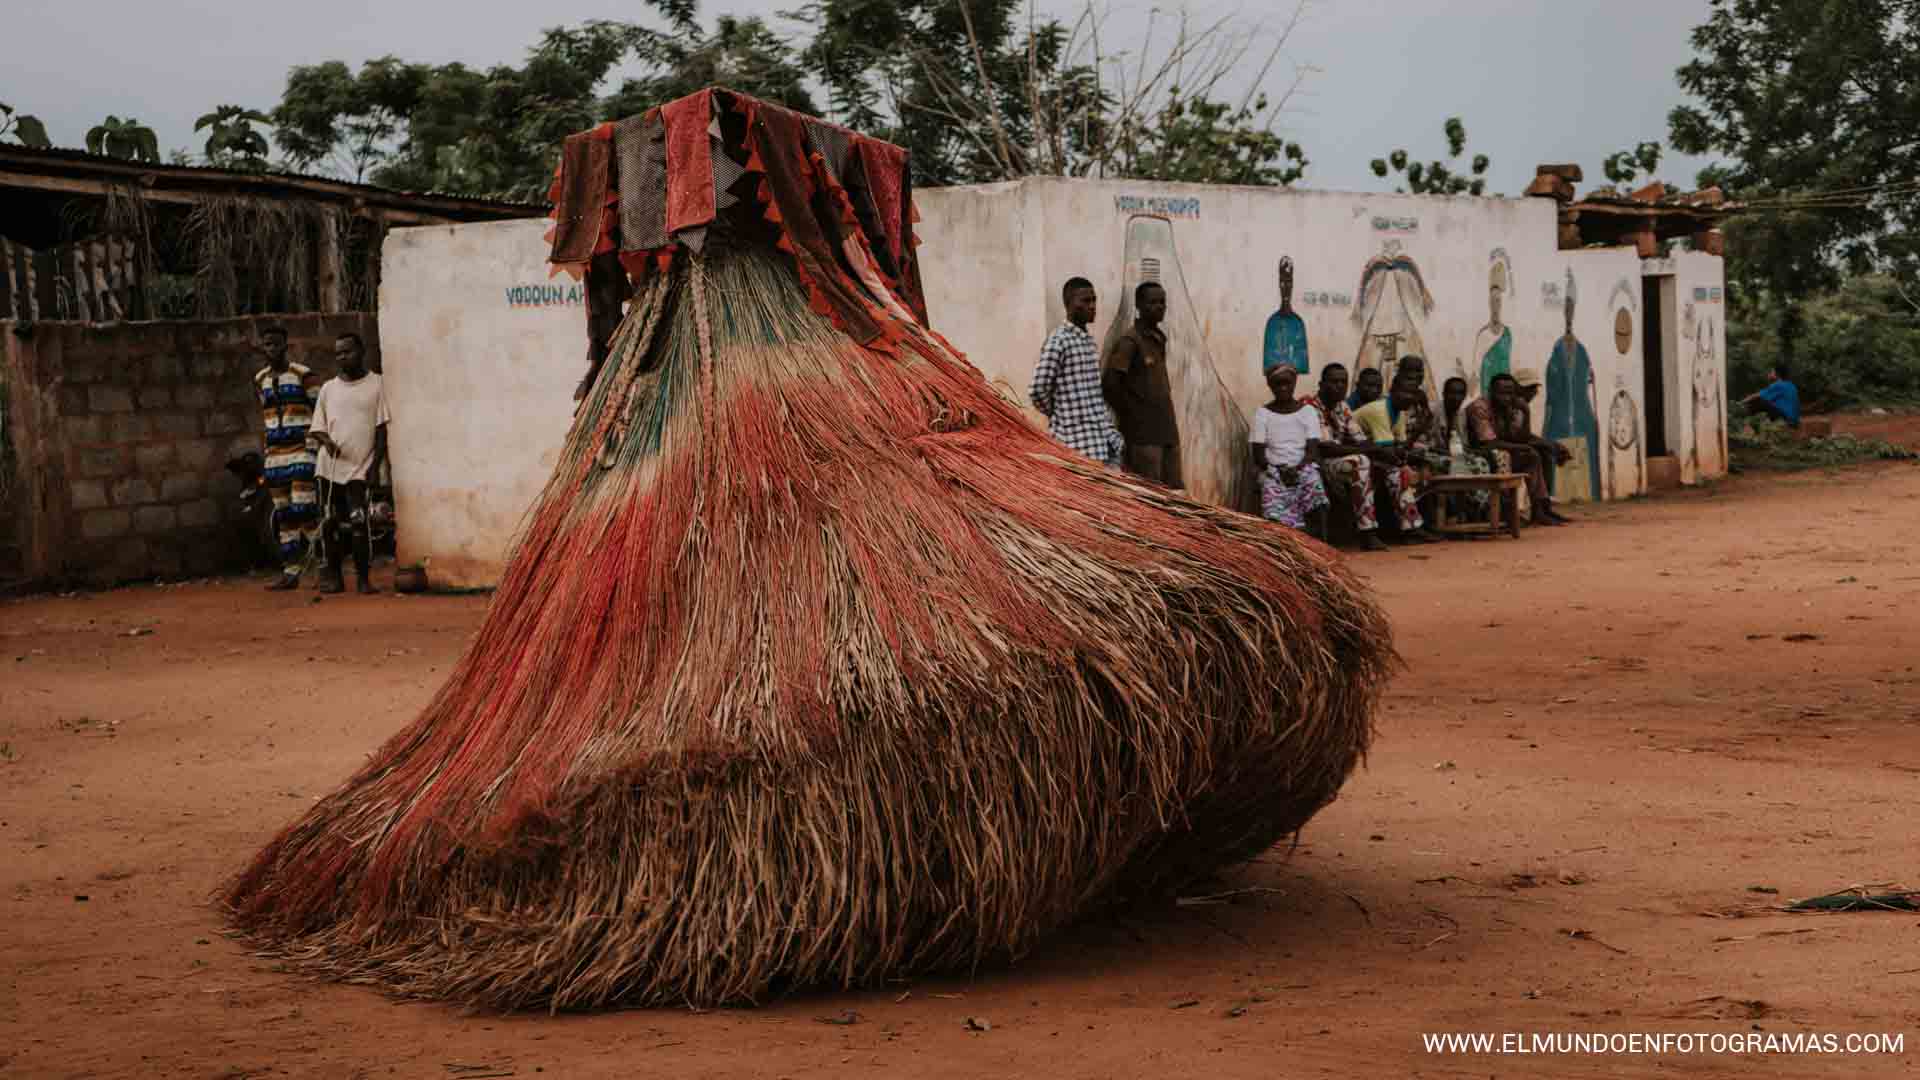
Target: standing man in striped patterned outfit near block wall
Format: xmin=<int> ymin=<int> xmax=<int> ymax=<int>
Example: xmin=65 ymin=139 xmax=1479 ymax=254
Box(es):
xmin=253 ymin=327 xmax=321 ymax=592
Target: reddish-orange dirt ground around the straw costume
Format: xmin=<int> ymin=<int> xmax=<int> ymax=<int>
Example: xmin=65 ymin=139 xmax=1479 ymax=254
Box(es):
xmin=0 ymin=417 xmax=1920 ymax=1080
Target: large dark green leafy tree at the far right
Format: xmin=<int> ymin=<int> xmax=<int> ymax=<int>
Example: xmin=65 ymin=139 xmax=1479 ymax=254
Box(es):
xmin=1668 ymin=0 xmax=1920 ymax=305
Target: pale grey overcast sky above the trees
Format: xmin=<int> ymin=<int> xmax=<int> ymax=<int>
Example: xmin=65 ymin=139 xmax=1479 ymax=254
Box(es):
xmin=0 ymin=0 xmax=1709 ymax=194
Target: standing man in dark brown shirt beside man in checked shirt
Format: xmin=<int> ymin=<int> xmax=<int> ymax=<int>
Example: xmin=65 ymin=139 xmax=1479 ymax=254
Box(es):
xmin=1100 ymin=281 xmax=1183 ymax=488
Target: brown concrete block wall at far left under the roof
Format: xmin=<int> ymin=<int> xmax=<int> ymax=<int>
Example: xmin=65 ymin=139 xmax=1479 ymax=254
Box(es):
xmin=0 ymin=313 xmax=378 ymax=586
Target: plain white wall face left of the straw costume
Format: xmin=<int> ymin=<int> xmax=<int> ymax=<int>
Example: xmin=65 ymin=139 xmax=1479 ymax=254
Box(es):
xmin=380 ymin=219 xmax=588 ymax=588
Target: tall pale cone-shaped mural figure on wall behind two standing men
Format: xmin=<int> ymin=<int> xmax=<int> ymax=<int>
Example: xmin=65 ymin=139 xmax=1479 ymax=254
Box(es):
xmin=1100 ymin=213 xmax=1258 ymax=511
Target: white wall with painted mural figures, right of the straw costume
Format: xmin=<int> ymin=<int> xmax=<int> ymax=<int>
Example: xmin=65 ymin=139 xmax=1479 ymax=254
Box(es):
xmin=916 ymin=179 xmax=1726 ymax=498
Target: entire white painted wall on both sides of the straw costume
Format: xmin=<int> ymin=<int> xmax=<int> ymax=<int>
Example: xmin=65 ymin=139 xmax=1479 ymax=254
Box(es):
xmin=380 ymin=179 xmax=1726 ymax=586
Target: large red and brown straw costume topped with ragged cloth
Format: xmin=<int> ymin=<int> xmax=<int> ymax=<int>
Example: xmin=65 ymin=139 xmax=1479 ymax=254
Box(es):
xmin=225 ymin=90 xmax=1394 ymax=1009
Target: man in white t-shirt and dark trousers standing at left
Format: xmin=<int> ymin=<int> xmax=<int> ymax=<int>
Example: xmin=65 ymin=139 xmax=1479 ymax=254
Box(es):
xmin=307 ymin=334 xmax=390 ymax=594
